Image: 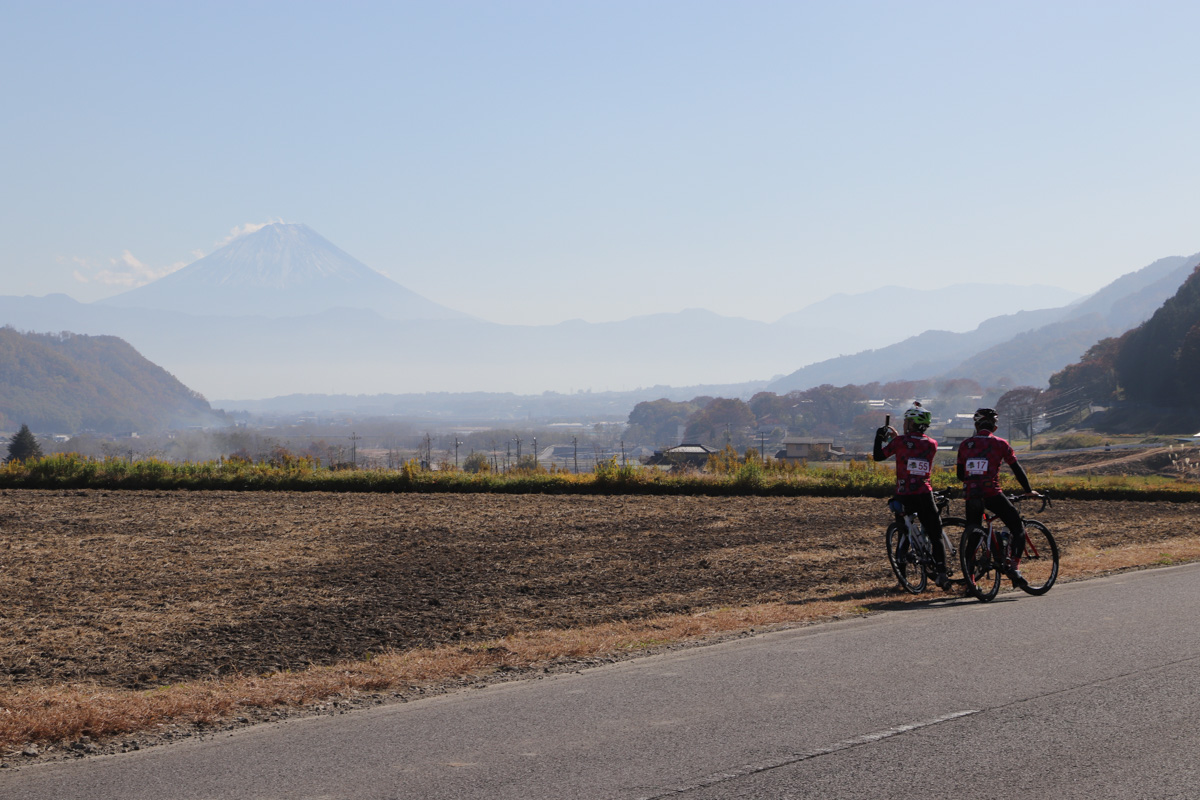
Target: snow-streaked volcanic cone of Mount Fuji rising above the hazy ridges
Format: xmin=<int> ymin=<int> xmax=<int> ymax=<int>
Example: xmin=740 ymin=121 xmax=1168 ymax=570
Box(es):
xmin=96 ymin=223 xmax=469 ymax=320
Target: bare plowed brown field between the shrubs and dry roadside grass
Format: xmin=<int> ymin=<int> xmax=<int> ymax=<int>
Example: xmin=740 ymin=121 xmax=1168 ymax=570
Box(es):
xmin=0 ymin=491 xmax=1200 ymax=690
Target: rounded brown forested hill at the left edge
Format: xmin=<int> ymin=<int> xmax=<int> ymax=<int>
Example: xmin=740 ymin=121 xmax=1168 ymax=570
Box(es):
xmin=0 ymin=327 xmax=218 ymax=433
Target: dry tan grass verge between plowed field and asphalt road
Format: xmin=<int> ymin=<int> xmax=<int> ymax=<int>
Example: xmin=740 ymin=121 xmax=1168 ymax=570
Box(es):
xmin=0 ymin=536 xmax=1200 ymax=754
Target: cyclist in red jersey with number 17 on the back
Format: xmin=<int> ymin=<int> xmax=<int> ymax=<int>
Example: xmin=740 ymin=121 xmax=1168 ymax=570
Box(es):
xmin=958 ymin=408 xmax=1042 ymax=587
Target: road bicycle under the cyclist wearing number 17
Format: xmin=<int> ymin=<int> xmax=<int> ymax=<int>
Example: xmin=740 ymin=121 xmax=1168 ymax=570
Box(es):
xmin=959 ymin=494 xmax=1058 ymax=602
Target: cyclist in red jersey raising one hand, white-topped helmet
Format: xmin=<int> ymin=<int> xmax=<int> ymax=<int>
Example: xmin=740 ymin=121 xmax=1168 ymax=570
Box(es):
xmin=872 ymin=403 xmax=950 ymax=589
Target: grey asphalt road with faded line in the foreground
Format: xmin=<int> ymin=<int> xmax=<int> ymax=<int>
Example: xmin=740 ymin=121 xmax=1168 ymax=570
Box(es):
xmin=0 ymin=565 xmax=1200 ymax=800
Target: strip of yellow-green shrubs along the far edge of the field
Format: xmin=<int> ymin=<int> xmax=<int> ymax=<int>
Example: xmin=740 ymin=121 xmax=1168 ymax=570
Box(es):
xmin=0 ymin=451 xmax=1200 ymax=500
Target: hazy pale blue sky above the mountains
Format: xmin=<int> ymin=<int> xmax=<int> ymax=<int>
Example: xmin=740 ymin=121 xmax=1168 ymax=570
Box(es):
xmin=0 ymin=0 xmax=1200 ymax=323
